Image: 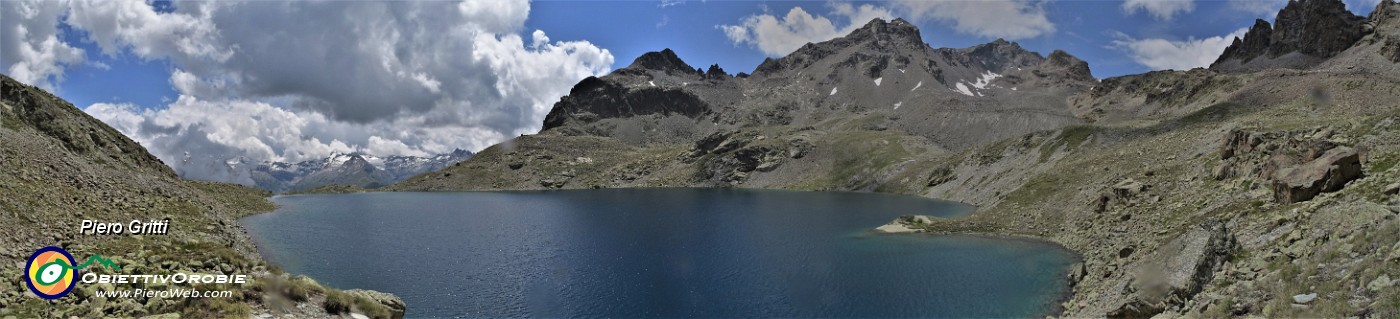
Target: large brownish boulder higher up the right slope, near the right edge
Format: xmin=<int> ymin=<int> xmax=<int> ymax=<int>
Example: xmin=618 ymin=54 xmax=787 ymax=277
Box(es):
xmin=1273 ymin=147 xmax=1362 ymax=203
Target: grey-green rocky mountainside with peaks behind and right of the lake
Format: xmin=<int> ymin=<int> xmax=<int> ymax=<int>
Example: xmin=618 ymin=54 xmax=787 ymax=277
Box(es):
xmin=388 ymin=6 xmax=1400 ymax=318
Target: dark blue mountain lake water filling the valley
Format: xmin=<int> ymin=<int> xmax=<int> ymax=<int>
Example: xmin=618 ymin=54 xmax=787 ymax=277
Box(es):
xmin=242 ymin=189 xmax=1075 ymax=318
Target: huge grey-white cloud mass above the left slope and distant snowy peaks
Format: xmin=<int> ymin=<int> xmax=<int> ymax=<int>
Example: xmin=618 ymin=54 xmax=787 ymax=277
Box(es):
xmin=0 ymin=0 xmax=613 ymax=182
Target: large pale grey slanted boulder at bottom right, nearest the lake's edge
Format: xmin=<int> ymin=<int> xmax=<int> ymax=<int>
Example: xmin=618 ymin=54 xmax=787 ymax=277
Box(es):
xmin=1106 ymin=221 xmax=1236 ymax=318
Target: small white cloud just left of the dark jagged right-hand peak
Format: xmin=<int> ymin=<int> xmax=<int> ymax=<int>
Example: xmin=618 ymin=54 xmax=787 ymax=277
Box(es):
xmin=1112 ymin=29 xmax=1247 ymax=70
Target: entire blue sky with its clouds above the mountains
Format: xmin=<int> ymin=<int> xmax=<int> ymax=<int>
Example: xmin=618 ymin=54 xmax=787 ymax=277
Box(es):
xmin=0 ymin=0 xmax=1379 ymax=178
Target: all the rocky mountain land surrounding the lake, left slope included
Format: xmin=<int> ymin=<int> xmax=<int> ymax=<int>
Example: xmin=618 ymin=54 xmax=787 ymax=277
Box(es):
xmin=0 ymin=0 xmax=1400 ymax=318
